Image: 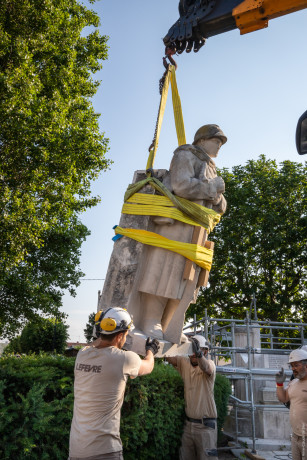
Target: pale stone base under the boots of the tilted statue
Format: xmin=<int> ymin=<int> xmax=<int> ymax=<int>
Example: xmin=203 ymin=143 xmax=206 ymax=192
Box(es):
xmin=124 ymin=329 xmax=193 ymax=358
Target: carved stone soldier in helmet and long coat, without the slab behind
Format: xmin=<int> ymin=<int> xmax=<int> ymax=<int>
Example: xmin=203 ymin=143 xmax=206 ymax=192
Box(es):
xmin=138 ymin=125 xmax=227 ymax=343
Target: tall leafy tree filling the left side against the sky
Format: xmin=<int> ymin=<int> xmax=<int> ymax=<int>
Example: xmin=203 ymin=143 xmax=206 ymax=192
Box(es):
xmin=0 ymin=0 xmax=109 ymax=335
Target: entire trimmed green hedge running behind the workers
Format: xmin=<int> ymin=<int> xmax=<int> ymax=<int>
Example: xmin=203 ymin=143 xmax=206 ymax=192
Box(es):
xmin=0 ymin=355 xmax=230 ymax=460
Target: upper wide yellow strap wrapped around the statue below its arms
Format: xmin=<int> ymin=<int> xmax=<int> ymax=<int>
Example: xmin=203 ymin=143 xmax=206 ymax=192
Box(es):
xmin=122 ymin=193 xmax=220 ymax=233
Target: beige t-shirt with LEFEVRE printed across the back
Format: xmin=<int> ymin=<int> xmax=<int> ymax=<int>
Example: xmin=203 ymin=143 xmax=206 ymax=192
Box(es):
xmin=69 ymin=346 xmax=141 ymax=458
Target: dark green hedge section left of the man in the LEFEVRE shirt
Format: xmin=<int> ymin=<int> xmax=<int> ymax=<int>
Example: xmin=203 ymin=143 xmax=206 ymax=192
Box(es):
xmin=0 ymin=355 xmax=74 ymax=460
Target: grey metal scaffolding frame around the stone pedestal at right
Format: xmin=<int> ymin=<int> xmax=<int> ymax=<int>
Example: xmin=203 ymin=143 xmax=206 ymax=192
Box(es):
xmin=184 ymin=310 xmax=307 ymax=453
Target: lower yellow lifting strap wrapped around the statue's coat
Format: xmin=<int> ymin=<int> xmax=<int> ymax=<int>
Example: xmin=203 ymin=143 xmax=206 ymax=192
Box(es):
xmin=115 ymin=226 xmax=213 ymax=271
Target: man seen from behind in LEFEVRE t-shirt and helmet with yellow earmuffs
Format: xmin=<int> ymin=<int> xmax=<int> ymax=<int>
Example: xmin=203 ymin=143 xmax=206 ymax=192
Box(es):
xmin=69 ymin=307 xmax=159 ymax=460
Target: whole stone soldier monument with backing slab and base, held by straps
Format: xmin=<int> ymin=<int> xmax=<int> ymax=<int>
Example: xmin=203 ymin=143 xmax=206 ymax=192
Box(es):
xmin=98 ymin=125 xmax=227 ymax=356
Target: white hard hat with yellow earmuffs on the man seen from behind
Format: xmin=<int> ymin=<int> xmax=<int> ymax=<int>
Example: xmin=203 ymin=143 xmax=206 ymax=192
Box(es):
xmin=95 ymin=307 xmax=134 ymax=337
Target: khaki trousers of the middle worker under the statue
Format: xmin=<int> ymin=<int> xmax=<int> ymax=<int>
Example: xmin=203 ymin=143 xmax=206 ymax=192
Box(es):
xmin=179 ymin=420 xmax=218 ymax=460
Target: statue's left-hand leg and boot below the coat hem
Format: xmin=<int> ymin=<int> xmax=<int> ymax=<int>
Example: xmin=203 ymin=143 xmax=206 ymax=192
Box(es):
xmin=141 ymin=292 xmax=167 ymax=340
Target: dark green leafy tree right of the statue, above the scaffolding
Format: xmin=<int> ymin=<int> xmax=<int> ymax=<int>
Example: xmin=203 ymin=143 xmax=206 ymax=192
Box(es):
xmin=188 ymin=155 xmax=307 ymax=322
